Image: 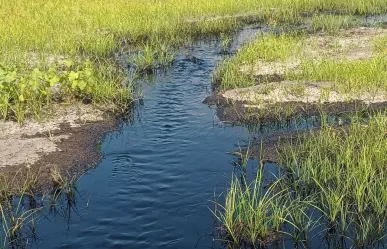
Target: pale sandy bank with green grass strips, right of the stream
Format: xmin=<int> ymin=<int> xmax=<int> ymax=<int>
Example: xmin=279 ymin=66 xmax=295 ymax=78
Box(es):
xmin=214 ymin=28 xmax=387 ymax=121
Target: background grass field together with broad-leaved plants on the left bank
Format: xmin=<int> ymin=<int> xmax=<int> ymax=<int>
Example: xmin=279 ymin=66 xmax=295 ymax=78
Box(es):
xmin=0 ymin=0 xmax=387 ymax=122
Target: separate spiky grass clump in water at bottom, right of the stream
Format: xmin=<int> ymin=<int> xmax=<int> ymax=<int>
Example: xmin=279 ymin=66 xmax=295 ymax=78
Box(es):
xmin=214 ymin=170 xmax=290 ymax=247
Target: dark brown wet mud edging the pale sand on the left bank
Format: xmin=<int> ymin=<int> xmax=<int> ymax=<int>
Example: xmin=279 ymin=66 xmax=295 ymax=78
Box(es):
xmin=0 ymin=118 xmax=118 ymax=194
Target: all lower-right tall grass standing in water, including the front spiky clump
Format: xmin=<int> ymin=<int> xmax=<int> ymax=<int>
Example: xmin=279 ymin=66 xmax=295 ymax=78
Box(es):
xmin=214 ymin=113 xmax=387 ymax=247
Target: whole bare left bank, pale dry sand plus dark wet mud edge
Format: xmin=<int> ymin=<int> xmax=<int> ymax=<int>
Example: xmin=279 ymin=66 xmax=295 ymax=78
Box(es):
xmin=0 ymin=105 xmax=117 ymax=192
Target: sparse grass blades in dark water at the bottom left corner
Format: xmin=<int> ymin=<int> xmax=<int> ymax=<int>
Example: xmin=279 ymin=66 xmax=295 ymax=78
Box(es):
xmin=0 ymin=168 xmax=81 ymax=248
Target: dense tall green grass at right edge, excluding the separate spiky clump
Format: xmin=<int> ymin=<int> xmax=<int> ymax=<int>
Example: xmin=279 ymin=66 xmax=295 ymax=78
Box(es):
xmin=279 ymin=114 xmax=387 ymax=247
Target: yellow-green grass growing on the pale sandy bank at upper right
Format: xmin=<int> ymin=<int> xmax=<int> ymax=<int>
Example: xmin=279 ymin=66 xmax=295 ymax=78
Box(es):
xmin=214 ymin=24 xmax=387 ymax=98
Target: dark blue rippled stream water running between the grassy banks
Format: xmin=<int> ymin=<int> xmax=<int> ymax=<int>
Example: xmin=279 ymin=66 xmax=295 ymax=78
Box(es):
xmin=27 ymin=29 xmax=264 ymax=249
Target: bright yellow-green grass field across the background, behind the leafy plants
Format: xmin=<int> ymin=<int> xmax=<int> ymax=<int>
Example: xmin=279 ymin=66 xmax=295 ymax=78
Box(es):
xmin=0 ymin=0 xmax=387 ymax=64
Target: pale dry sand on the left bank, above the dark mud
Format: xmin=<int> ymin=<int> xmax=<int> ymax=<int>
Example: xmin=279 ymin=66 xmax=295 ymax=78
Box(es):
xmin=0 ymin=106 xmax=103 ymax=167
